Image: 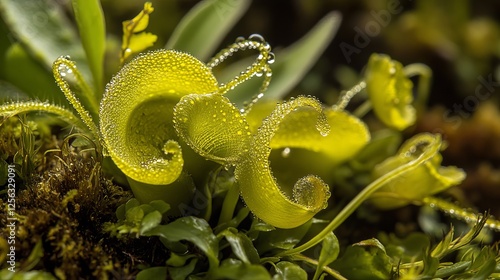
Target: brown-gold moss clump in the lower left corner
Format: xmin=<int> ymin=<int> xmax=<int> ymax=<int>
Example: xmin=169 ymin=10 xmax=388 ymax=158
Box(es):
xmin=0 ymin=152 xmax=166 ymax=279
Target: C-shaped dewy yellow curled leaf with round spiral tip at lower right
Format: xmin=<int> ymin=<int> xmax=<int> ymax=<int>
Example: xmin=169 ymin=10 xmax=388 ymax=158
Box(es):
xmin=235 ymin=97 xmax=330 ymax=228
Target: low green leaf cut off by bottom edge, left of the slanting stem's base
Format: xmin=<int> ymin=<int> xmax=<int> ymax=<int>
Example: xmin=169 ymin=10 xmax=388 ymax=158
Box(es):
xmin=210 ymin=259 xmax=271 ymax=280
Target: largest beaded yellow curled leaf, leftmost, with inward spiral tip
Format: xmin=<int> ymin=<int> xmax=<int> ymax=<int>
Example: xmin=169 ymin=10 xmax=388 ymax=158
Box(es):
xmin=99 ymin=50 xmax=218 ymax=185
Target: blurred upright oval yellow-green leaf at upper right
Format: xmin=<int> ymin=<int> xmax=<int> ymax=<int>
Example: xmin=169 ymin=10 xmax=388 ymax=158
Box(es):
xmin=365 ymin=54 xmax=416 ymax=130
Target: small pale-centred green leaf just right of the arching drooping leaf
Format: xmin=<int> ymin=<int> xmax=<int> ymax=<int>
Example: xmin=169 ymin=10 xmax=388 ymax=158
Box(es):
xmin=219 ymin=228 xmax=260 ymax=264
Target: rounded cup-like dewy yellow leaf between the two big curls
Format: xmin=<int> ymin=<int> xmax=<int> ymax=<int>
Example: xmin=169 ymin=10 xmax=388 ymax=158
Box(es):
xmin=174 ymin=94 xmax=250 ymax=164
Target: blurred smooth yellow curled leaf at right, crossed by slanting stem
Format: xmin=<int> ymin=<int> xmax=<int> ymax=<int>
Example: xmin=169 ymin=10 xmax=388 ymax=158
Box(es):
xmin=371 ymin=133 xmax=465 ymax=209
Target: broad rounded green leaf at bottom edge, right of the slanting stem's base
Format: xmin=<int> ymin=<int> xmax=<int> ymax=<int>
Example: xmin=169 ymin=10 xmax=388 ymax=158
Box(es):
xmin=332 ymin=238 xmax=392 ymax=279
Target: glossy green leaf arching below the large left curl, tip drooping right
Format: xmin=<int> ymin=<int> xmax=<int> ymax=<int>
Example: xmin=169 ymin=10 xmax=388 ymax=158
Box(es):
xmin=144 ymin=216 xmax=219 ymax=269
